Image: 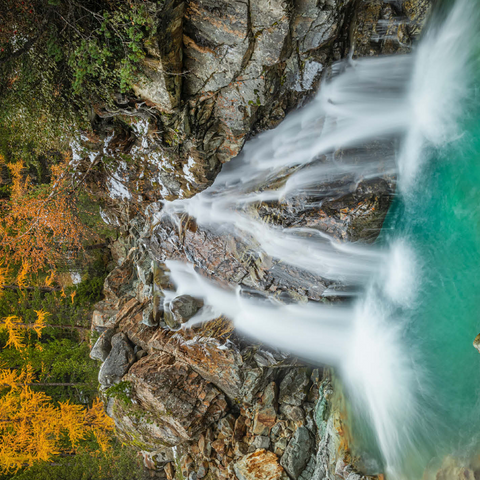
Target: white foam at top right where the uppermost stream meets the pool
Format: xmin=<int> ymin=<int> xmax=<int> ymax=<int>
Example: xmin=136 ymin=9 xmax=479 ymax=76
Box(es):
xmin=399 ymin=0 xmax=478 ymax=190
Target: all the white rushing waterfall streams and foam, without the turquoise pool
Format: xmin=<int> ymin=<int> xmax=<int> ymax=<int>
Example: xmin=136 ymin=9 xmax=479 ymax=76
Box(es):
xmin=152 ymin=0 xmax=474 ymax=480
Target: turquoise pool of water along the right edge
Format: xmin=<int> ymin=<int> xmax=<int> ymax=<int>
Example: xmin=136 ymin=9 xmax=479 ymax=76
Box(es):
xmin=356 ymin=94 xmax=480 ymax=480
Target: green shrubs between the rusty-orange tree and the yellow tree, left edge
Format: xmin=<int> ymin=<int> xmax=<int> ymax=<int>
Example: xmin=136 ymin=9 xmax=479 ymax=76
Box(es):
xmin=0 ymin=274 xmax=109 ymax=404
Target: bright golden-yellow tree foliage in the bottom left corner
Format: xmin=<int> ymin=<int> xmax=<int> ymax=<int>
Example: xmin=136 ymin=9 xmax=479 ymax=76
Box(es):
xmin=0 ymin=368 xmax=113 ymax=473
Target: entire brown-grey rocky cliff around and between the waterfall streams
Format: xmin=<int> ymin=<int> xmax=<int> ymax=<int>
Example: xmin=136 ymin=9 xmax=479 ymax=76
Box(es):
xmin=85 ymin=0 xmax=428 ymax=480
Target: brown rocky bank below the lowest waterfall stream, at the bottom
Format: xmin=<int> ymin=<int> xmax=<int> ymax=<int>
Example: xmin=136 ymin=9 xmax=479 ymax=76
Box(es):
xmin=92 ymin=238 xmax=386 ymax=480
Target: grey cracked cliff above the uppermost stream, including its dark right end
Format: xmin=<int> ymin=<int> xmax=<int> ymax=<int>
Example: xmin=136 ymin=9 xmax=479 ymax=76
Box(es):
xmin=124 ymin=0 xmax=430 ymax=200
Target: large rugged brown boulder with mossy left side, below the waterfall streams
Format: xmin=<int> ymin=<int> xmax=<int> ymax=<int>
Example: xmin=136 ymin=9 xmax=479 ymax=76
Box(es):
xmin=113 ymin=353 xmax=228 ymax=451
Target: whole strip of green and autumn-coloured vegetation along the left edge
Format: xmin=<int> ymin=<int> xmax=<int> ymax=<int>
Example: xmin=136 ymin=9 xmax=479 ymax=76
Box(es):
xmin=0 ymin=0 xmax=163 ymax=480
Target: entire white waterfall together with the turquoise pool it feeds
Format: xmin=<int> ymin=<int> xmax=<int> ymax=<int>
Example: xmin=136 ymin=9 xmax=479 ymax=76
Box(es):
xmin=154 ymin=0 xmax=480 ymax=480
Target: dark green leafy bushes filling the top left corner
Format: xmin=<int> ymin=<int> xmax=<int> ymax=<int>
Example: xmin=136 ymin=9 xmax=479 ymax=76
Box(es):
xmin=0 ymin=0 xmax=158 ymax=166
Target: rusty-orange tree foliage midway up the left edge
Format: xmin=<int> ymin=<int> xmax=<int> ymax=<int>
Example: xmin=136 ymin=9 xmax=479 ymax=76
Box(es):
xmin=0 ymin=160 xmax=88 ymax=274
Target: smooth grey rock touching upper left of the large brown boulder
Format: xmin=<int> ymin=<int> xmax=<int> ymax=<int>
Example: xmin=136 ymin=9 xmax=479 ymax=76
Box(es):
xmin=98 ymin=333 xmax=135 ymax=386
